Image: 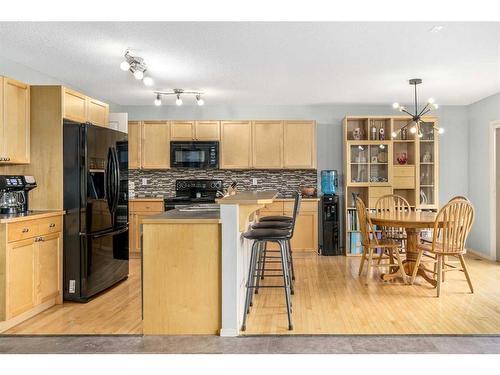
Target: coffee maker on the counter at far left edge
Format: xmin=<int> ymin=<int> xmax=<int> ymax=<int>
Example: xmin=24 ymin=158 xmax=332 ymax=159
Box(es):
xmin=0 ymin=175 xmax=36 ymax=214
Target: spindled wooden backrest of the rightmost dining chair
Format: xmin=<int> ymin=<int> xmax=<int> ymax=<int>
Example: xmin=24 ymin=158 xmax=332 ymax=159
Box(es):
xmin=432 ymin=199 xmax=474 ymax=253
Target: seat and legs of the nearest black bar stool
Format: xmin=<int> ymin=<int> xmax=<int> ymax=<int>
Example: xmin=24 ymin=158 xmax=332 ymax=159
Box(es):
xmin=241 ymin=228 xmax=293 ymax=331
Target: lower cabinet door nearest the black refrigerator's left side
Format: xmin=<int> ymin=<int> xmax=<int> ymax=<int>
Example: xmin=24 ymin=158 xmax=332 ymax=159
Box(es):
xmin=35 ymin=233 xmax=62 ymax=304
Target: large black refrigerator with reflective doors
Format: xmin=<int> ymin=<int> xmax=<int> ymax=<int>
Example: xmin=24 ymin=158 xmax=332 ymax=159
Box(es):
xmin=63 ymin=120 xmax=129 ymax=302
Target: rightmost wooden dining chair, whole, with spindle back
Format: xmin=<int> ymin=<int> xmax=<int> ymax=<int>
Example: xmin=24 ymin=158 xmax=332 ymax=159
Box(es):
xmin=411 ymin=199 xmax=474 ymax=297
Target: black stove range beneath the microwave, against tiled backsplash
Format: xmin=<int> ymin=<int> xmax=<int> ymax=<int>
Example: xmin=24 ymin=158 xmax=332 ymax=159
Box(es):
xmin=164 ymin=180 xmax=224 ymax=211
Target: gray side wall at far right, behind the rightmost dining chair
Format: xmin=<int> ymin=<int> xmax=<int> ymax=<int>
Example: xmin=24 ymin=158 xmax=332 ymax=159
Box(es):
xmin=468 ymin=93 xmax=500 ymax=256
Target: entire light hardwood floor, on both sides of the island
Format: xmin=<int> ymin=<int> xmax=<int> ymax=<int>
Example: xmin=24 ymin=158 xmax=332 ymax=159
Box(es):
xmin=5 ymin=253 xmax=500 ymax=335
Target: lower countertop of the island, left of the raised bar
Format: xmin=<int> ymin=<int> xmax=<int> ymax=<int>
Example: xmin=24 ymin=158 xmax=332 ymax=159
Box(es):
xmin=142 ymin=205 xmax=221 ymax=224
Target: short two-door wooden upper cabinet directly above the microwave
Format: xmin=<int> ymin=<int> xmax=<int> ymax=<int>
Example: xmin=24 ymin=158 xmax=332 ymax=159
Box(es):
xmin=170 ymin=121 xmax=220 ymax=141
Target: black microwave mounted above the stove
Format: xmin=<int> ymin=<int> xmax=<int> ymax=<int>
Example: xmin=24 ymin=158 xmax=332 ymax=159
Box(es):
xmin=170 ymin=141 xmax=219 ymax=168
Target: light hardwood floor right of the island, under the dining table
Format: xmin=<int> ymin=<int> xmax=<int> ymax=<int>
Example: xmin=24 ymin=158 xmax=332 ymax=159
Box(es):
xmin=243 ymin=253 xmax=500 ymax=335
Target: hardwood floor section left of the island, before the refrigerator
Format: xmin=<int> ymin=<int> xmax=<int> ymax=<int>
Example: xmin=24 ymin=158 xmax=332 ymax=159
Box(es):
xmin=4 ymin=259 xmax=142 ymax=335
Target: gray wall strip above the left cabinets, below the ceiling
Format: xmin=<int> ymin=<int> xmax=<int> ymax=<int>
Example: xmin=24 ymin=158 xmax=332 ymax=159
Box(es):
xmin=0 ymin=56 xmax=121 ymax=112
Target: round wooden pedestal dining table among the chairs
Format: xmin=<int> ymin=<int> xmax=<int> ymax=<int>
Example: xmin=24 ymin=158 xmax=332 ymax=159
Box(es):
xmin=370 ymin=211 xmax=442 ymax=286
